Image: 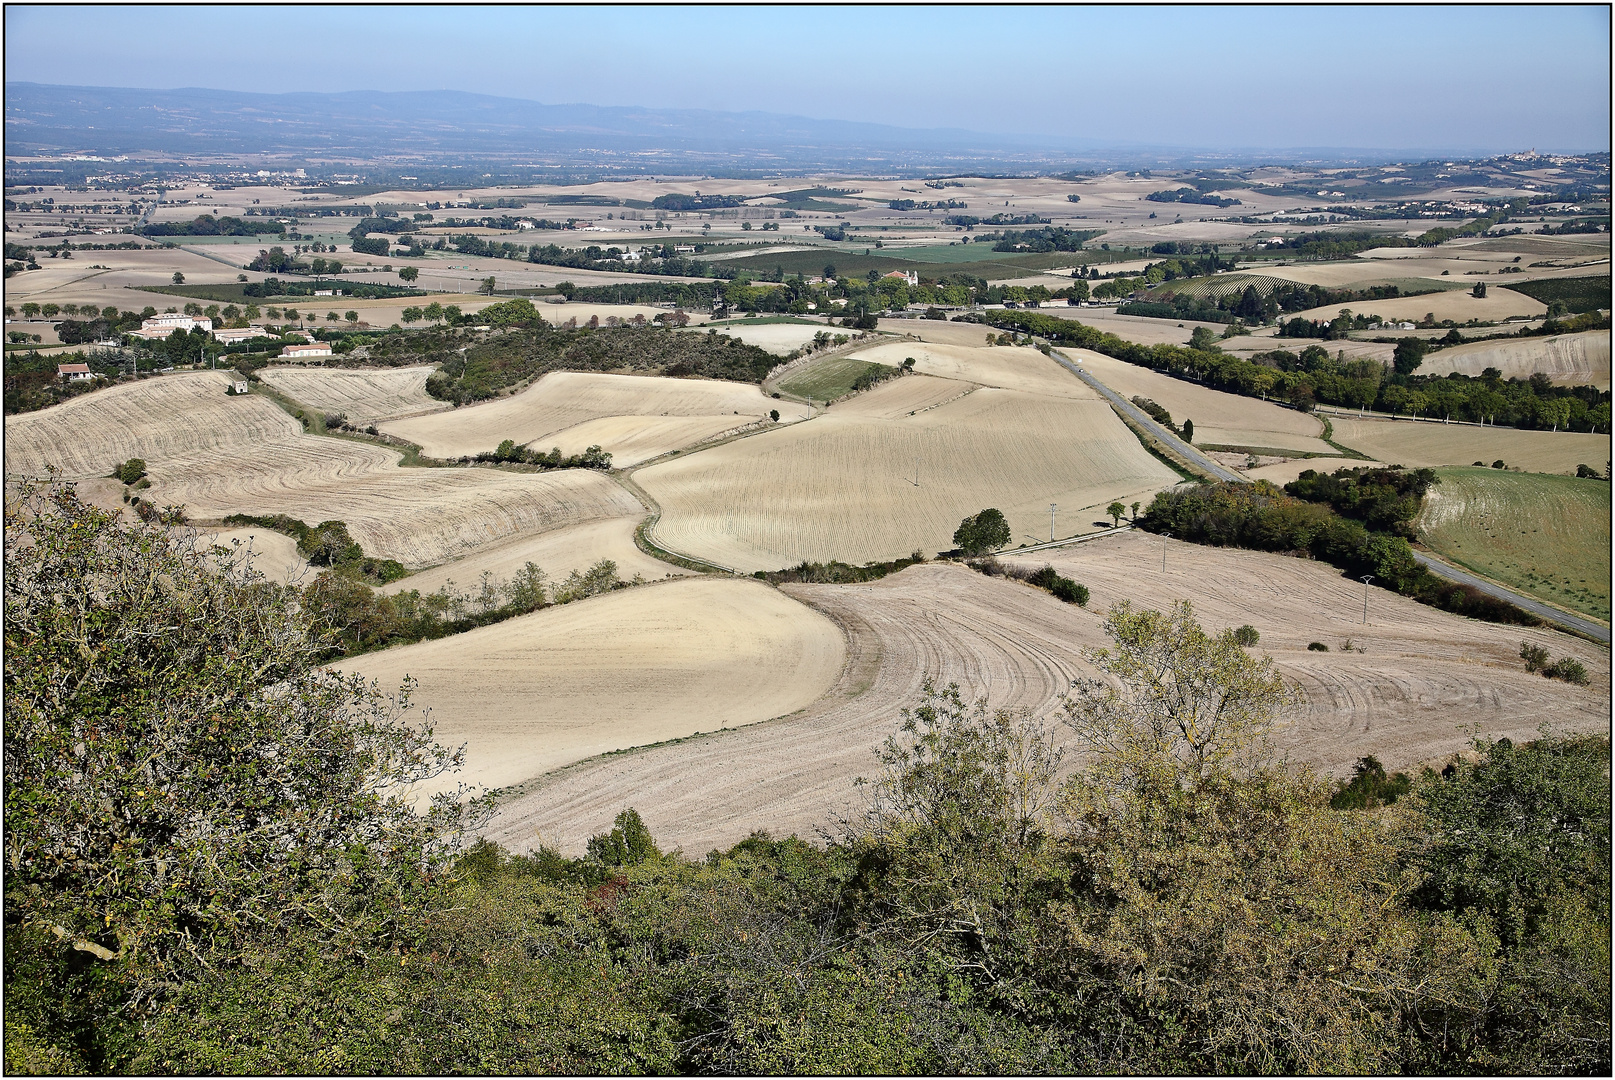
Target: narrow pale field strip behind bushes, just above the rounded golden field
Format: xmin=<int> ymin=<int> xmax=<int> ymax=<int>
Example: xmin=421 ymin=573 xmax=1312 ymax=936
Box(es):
xmin=381 ymin=513 xmax=694 ymax=594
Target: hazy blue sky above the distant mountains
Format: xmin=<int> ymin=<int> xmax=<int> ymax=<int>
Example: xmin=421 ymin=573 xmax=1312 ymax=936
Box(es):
xmin=5 ymin=5 xmax=1610 ymax=150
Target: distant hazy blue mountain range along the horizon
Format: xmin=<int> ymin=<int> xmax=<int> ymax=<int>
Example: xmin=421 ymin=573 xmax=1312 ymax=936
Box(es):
xmin=5 ymin=82 xmax=1440 ymax=173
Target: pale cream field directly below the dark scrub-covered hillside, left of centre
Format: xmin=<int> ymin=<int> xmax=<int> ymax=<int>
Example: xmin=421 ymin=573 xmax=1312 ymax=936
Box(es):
xmin=381 ymin=371 xmax=811 ymax=465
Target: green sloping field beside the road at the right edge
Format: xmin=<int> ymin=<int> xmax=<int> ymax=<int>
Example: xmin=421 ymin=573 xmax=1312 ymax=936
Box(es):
xmin=1418 ymin=462 xmax=1610 ymax=620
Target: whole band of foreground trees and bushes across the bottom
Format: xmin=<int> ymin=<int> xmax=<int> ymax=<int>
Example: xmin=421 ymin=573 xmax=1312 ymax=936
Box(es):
xmin=5 ymin=487 xmax=1610 ymax=1074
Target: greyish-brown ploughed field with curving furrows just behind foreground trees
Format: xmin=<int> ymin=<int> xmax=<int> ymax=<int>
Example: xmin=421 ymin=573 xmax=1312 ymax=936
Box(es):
xmin=486 ymin=533 xmax=1610 ymax=852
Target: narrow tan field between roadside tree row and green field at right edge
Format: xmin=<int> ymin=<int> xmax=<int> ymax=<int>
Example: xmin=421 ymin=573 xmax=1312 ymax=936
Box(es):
xmin=1331 ymin=417 xmax=1610 ymax=473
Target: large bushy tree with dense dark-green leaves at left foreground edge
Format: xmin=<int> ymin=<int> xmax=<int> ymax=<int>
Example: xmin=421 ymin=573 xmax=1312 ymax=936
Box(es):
xmin=5 ymin=484 xmax=480 ymax=1028
